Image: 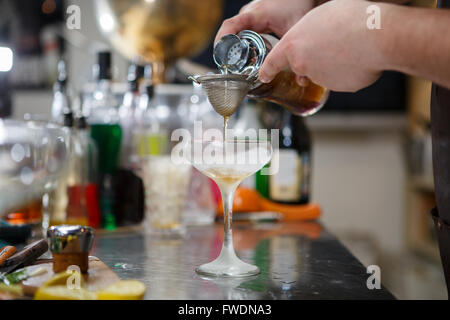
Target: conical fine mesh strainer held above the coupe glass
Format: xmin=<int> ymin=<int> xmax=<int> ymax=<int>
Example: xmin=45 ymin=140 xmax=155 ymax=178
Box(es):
xmin=190 ymin=74 xmax=255 ymax=117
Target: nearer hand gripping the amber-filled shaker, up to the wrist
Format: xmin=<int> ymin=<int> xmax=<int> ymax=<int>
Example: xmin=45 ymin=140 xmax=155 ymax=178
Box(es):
xmin=259 ymin=0 xmax=385 ymax=92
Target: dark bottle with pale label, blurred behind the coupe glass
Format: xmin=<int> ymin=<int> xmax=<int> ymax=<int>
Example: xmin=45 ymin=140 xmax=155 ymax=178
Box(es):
xmin=268 ymin=111 xmax=311 ymax=205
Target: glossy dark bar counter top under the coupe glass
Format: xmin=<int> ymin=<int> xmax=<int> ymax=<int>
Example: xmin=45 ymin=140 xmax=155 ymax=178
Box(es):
xmin=91 ymin=222 xmax=395 ymax=300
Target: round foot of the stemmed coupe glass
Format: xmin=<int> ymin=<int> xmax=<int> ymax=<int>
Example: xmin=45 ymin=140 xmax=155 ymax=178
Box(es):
xmin=195 ymin=247 xmax=260 ymax=277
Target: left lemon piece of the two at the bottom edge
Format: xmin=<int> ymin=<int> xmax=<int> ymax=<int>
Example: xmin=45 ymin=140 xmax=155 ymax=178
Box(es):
xmin=34 ymin=285 xmax=97 ymax=300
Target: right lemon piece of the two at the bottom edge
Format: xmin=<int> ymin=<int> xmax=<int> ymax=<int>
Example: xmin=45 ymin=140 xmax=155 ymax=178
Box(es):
xmin=97 ymin=280 xmax=146 ymax=300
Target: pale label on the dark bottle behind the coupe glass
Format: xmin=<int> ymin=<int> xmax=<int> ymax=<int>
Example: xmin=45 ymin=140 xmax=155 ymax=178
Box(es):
xmin=269 ymin=150 xmax=302 ymax=202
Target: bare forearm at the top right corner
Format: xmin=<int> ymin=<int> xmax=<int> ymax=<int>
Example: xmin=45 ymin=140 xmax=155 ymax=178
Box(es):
xmin=373 ymin=4 xmax=450 ymax=88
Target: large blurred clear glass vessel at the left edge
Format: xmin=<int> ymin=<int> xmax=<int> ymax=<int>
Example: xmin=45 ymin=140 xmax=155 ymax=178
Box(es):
xmin=0 ymin=119 xmax=69 ymax=231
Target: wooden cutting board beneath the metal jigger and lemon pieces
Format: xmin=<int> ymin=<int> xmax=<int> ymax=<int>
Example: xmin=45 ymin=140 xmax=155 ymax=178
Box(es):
xmin=22 ymin=256 xmax=120 ymax=295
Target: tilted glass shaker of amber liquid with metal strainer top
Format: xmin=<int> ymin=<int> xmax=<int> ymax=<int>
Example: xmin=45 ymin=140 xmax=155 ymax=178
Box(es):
xmin=213 ymin=30 xmax=329 ymax=116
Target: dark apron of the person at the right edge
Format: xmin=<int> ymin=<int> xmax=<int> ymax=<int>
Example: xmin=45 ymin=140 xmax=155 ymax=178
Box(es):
xmin=431 ymin=0 xmax=450 ymax=297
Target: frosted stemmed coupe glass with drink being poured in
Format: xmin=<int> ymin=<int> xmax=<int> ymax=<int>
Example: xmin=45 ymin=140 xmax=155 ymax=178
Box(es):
xmin=187 ymin=140 xmax=272 ymax=277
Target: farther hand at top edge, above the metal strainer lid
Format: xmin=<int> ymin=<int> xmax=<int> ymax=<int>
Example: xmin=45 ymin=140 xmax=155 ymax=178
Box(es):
xmin=214 ymin=0 xmax=314 ymax=43
